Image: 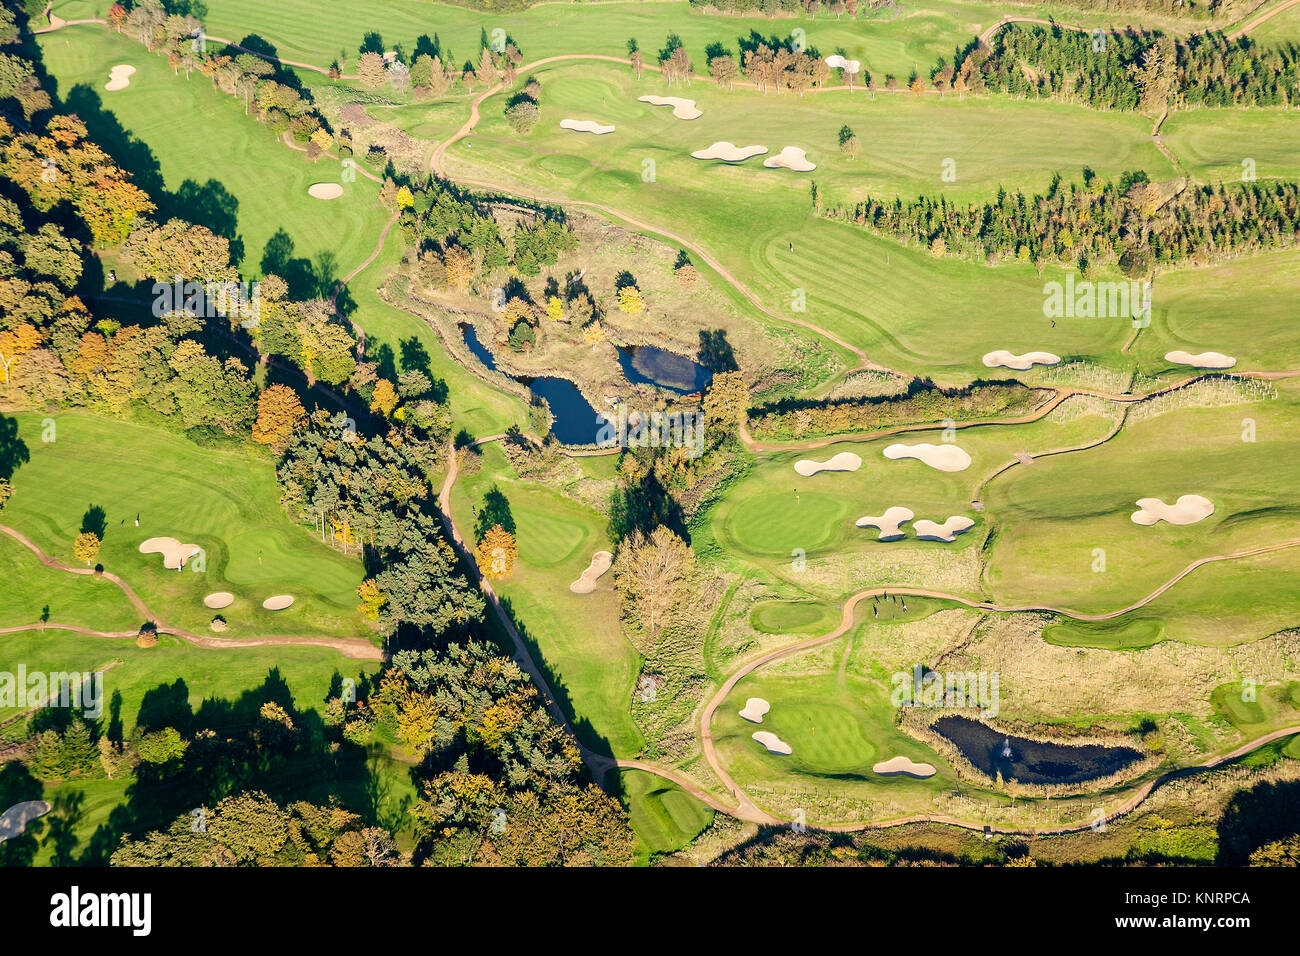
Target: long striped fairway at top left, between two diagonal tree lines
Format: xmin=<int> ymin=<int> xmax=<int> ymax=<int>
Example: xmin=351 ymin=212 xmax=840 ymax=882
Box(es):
xmin=40 ymin=25 xmax=387 ymax=278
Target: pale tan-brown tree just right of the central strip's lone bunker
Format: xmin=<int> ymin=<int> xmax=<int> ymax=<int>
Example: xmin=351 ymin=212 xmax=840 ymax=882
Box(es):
xmin=614 ymin=524 xmax=696 ymax=653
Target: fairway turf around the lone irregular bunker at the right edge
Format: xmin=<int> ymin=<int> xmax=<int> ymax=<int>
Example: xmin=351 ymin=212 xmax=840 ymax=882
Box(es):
xmin=985 ymin=381 xmax=1300 ymax=643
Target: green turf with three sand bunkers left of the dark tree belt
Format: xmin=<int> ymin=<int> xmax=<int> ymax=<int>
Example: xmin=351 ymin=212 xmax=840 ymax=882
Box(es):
xmin=3 ymin=412 xmax=372 ymax=637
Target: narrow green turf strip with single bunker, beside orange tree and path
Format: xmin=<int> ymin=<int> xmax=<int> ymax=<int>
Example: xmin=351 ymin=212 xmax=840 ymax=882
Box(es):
xmin=451 ymin=444 xmax=641 ymax=756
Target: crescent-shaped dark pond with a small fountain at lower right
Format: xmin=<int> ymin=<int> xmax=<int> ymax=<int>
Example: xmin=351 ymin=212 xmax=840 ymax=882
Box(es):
xmin=933 ymin=717 xmax=1143 ymax=784
